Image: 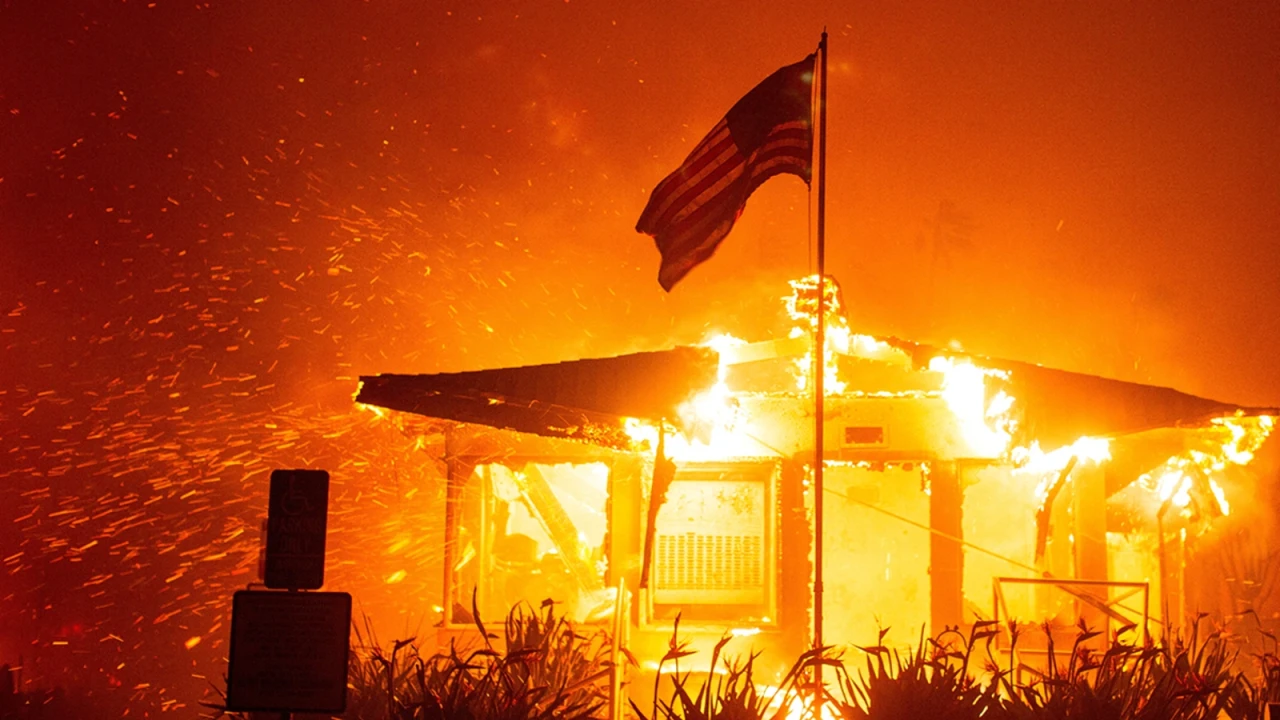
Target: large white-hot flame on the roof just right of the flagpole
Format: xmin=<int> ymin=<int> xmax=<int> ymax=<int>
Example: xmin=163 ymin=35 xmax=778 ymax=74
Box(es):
xmin=929 ymin=355 xmax=1014 ymax=457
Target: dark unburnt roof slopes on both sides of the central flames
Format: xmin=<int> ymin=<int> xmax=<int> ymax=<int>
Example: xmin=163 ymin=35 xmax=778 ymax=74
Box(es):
xmin=356 ymin=338 xmax=1280 ymax=450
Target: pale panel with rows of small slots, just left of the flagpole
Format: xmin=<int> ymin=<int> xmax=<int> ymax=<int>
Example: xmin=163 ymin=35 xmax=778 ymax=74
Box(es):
xmin=655 ymin=533 xmax=764 ymax=591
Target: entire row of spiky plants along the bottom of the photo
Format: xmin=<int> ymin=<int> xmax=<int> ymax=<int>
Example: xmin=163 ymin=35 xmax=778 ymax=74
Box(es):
xmin=210 ymin=602 xmax=1280 ymax=720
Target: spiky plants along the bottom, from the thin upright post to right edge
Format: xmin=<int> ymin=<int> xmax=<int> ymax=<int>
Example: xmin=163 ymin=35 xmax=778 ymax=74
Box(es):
xmin=645 ymin=609 xmax=1280 ymax=720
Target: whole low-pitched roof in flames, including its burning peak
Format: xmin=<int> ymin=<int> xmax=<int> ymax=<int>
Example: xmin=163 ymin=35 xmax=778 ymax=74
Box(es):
xmin=356 ymin=275 xmax=1277 ymax=495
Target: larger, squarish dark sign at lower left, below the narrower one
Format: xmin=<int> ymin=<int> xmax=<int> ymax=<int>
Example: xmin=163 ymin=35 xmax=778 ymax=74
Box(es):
xmin=227 ymin=591 xmax=351 ymax=714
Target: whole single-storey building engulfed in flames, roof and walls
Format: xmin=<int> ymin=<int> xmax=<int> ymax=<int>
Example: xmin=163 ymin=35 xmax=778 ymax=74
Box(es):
xmin=356 ymin=278 xmax=1277 ymax=660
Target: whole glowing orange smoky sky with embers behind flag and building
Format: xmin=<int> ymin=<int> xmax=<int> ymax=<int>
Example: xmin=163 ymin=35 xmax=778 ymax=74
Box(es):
xmin=0 ymin=0 xmax=1280 ymax=702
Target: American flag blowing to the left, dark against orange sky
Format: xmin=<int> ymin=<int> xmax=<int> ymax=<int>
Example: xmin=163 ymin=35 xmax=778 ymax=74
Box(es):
xmin=636 ymin=55 xmax=814 ymax=291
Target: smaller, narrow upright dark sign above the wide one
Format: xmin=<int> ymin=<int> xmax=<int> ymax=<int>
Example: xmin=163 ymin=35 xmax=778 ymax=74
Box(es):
xmin=262 ymin=470 xmax=329 ymax=589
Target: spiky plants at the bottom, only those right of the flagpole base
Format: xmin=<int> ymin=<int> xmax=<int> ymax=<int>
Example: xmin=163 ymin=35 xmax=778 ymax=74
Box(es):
xmin=841 ymin=619 xmax=1280 ymax=720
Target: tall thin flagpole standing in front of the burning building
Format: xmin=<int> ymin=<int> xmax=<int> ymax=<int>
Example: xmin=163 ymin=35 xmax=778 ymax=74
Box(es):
xmin=813 ymin=28 xmax=827 ymax=720
